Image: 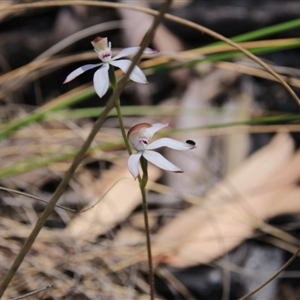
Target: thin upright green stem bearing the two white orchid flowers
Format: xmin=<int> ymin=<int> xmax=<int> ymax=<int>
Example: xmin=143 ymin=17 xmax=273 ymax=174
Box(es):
xmin=108 ymin=66 xmax=154 ymax=300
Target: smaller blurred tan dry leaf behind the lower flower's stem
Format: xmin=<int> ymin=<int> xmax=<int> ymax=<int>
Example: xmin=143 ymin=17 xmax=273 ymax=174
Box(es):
xmin=66 ymin=161 xmax=161 ymax=241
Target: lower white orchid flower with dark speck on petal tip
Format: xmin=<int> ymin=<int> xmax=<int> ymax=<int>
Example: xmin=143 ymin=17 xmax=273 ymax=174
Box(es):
xmin=127 ymin=123 xmax=196 ymax=179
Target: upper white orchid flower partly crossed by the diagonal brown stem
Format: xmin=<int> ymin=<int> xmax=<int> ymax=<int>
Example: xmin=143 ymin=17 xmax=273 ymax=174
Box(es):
xmin=64 ymin=36 xmax=156 ymax=98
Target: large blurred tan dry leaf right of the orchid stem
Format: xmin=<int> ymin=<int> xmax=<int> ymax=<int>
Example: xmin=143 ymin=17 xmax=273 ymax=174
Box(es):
xmin=154 ymin=133 xmax=300 ymax=267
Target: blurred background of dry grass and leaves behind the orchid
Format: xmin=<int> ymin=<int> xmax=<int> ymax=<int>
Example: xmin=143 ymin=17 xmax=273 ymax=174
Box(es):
xmin=0 ymin=0 xmax=300 ymax=300
